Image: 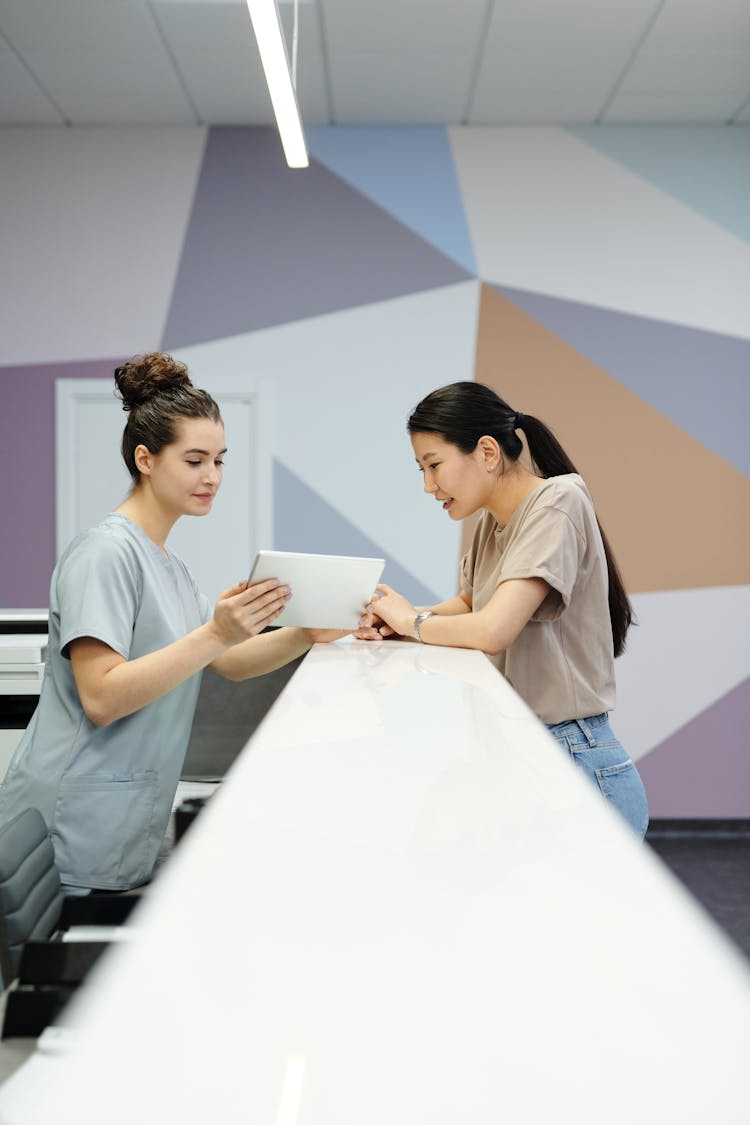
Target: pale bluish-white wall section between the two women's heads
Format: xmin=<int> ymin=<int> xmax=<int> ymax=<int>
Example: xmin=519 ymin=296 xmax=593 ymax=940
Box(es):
xmin=175 ymin=281 xmax=478 ymax=596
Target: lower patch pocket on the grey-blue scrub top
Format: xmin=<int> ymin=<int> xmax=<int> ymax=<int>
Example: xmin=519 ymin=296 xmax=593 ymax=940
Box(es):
xmin=52 ymin=770 xmax=157 ymax=890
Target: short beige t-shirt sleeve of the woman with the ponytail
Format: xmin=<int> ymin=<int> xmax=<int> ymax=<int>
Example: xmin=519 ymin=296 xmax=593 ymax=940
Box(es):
xmin=501 ymin=507 xmax=585 ymax=621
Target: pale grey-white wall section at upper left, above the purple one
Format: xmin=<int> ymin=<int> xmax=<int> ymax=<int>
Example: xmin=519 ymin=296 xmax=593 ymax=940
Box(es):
xmin=0 ymin=127 xmax=206 ymax=363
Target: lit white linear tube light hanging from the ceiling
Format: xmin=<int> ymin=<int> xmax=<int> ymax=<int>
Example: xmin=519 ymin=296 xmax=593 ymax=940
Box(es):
xmin=247 ymin=0 xmax=310 ymax=168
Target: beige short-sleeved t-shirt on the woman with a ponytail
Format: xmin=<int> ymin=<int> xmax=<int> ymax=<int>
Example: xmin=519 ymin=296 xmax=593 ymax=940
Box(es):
xmin=461 ymin=473 xmax=615 ymax=722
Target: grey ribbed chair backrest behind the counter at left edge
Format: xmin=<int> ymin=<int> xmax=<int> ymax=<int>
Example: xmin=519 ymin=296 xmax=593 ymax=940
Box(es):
xmin=0 ymin=809 xmax=63 ymax=987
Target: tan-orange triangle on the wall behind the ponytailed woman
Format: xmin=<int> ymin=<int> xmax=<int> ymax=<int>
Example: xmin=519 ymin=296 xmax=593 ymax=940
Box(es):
xmin=462 ymin=285 xmax=750 ymax=593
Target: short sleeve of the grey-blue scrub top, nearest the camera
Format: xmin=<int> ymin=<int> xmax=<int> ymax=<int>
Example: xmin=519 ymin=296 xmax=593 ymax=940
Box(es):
xmin=56 ymin=534 xmax=142 ymax=659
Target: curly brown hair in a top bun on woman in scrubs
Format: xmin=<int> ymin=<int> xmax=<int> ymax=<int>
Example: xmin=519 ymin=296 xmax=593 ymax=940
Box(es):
xmin=115 ymin=352 xmax=222 ymax=485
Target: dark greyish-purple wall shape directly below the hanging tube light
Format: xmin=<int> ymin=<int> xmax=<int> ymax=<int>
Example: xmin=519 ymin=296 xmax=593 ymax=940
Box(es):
xmin=163 ymin=127 xmax=471 ymax=348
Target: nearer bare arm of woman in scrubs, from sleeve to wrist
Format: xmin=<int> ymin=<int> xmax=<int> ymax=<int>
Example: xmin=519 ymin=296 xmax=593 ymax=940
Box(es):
xmin=71 ymin=622 xmax=227 ymax=727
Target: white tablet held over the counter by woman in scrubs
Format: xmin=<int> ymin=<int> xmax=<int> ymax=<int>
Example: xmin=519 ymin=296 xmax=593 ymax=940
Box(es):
xmin=250 ymin=551 xmax=386 ymax=629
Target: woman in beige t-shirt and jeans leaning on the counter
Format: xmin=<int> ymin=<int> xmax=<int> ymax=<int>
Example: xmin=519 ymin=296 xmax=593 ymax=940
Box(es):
xmin=360 ymin=383 xmax=649 ymax=836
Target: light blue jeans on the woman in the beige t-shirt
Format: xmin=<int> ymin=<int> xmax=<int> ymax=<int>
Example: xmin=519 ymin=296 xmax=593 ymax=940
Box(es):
xmin=548 ymin=712 xmax=649 ymax=839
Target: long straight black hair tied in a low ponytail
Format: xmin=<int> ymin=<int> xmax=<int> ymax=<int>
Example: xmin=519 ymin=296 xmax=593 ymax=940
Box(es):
xmin=406 ymin=381 xmax=633 ymax=656
